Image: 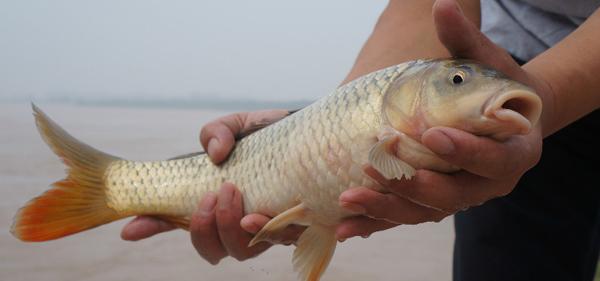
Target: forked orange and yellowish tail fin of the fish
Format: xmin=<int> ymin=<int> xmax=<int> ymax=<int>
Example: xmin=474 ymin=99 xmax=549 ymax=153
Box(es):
xmin=11 ymin=105 xmax=123 ymax=242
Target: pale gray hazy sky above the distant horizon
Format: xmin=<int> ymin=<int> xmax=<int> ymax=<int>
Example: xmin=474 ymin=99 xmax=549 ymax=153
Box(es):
xmin=0 ymin=0 xmax=386 ymax=100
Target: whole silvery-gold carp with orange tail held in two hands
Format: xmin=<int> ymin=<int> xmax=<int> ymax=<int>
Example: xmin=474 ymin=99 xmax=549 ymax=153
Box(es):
xmin=11 ymin=59 xmax=542 ymax=281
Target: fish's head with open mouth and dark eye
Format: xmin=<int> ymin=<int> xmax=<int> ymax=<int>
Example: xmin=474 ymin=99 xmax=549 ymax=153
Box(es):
xmin=382 ymin=59 xmax=542 ymax=140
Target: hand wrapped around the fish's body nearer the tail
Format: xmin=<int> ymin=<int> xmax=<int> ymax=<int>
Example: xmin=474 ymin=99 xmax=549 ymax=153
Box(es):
xmin=121 ymin=110 xmax=302 ymax=264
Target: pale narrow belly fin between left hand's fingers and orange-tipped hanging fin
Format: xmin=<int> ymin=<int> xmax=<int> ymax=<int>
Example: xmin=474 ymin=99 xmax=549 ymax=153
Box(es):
xmin=248 ymin=203 xmax=310 ymax=247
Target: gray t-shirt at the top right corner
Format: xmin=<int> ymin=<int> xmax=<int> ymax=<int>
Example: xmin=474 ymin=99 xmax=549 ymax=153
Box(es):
xmin=481 ymin=0 xmax=600 ymax=61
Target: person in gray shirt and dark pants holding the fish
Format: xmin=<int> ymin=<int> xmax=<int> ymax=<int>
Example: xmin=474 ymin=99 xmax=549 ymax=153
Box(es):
xmin=122 ymin=0 xmax=600 ymax=280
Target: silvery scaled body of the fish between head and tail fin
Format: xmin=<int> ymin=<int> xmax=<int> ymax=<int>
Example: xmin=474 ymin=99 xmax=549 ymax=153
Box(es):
xmin=106 ymin=62 xmax=402 ymax=220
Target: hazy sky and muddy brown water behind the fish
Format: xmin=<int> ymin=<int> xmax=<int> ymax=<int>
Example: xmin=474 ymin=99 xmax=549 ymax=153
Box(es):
xmin=0 ymin=0 xmax=454 ymax=281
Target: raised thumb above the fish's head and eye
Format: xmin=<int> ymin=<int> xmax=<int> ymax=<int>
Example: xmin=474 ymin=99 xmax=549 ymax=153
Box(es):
xmin=433 ymin=0 xmax=524 ymax=82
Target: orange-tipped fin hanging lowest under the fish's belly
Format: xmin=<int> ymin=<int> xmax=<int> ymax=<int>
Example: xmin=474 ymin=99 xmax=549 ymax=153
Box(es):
xmin=292 ymin=224 xmax=337 ymax=281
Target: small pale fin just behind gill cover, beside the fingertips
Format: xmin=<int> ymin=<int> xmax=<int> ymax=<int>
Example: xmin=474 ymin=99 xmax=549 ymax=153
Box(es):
xmin=369 ymin=136 xmax=415 ymax=179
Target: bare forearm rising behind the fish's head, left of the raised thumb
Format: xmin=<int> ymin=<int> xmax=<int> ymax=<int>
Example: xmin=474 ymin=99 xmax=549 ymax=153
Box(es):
xmin=342 ymin=0 xmax=480 ymax=83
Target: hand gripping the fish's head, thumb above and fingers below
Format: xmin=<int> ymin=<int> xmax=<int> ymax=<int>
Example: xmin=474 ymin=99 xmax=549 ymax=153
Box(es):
xmin=336 ymin=0 xmax=552 ymax=239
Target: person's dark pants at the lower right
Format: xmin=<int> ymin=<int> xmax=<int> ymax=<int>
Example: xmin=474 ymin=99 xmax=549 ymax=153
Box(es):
xmin=454 ymin=55 xmax=600 ymax=281
